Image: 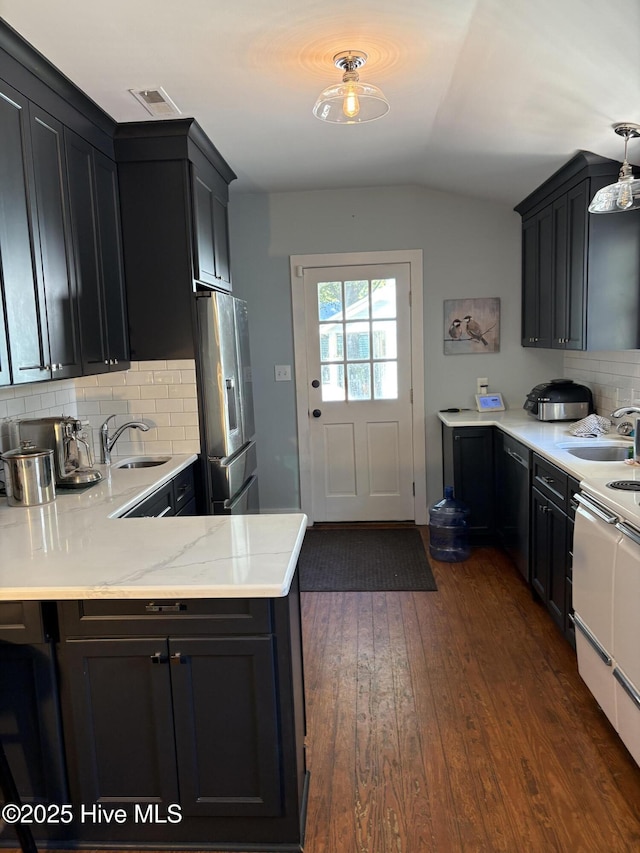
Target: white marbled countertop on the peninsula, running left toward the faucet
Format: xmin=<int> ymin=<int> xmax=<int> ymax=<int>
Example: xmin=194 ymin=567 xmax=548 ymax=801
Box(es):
xmin=0 ymin=455 xmax=307 ymax=601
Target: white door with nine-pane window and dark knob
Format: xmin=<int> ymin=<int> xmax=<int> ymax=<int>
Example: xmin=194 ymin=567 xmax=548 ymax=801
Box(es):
xmin=304 ymin=263 xmax=415 ymax=521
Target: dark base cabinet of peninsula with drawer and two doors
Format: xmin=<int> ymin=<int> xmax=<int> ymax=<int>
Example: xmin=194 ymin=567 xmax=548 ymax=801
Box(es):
xmin=59 ymin=578 xmax=307 ymax=851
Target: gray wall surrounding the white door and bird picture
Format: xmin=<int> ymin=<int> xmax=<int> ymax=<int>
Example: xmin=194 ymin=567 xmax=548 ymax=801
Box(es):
xmin=230 ymin=187 xmax=562 ymax=512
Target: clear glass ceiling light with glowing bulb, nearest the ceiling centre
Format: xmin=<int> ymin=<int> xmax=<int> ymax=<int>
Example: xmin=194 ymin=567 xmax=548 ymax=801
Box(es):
xmin=313 ymin=50 xmax=389 ymax=124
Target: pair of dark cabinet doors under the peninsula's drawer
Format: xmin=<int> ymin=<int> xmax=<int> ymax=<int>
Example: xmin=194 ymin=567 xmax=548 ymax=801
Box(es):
xmin=64 ymin=636 xmax=282 ymax=840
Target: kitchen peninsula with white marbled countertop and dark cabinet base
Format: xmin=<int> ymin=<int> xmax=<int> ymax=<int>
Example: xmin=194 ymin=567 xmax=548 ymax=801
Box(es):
xmin=0 ymin=455 xmax=308 ymax=851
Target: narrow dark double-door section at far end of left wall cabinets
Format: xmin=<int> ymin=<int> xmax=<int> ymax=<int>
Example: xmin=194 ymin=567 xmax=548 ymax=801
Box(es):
xmin=65 ymin=130 xmax=129 ymax=373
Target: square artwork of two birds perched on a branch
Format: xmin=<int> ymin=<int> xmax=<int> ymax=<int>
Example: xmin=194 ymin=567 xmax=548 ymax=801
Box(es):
xmin=444 ymin=297 xmax=500 ymax=355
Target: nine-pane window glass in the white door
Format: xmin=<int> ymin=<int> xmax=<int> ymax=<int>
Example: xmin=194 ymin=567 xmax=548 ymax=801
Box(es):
xmin=318 ymin=278 xmax=398 ymax=402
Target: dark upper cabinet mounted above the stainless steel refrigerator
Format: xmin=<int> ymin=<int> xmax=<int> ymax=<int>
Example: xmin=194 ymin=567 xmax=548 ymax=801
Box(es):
xmin=115 ymin=119 xmax=235 ymax=360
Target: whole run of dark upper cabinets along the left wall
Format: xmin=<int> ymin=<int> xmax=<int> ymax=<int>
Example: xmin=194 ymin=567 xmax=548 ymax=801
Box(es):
xmin=0 ymin=20 xmax=128 ymax=385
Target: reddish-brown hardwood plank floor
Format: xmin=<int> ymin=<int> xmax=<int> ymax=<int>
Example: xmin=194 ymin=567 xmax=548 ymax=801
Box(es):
xmin=303 ymin=536 xmax=640 ymax=853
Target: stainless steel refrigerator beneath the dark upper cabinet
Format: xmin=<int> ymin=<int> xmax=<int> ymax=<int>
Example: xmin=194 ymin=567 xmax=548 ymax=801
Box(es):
xmin=196 ymin=291 xmax=260 ymax=515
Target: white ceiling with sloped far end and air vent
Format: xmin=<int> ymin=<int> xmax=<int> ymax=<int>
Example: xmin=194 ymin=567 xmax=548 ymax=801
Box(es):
xmin=0 ymin=0 xmax=640 ymax=205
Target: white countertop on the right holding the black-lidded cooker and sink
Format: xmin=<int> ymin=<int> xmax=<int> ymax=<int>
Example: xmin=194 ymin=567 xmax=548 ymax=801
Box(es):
xmin=438 ymin=410 xmax=640 ymax=528
